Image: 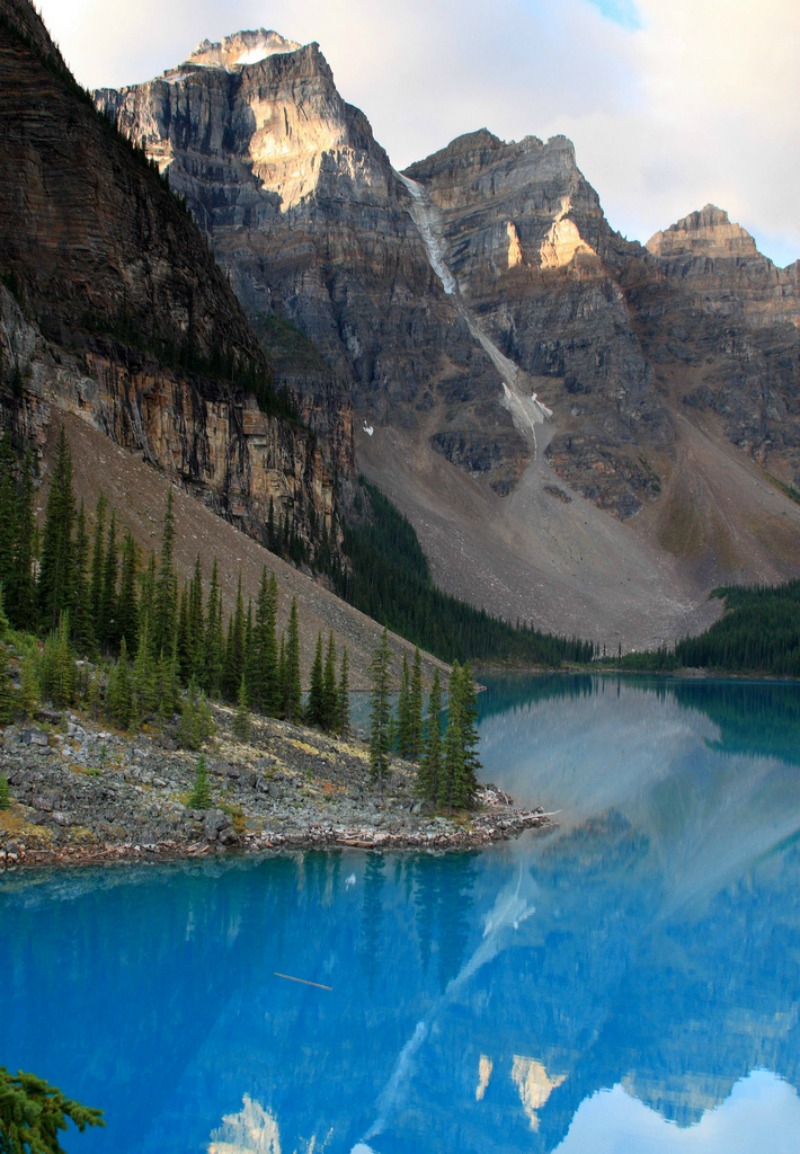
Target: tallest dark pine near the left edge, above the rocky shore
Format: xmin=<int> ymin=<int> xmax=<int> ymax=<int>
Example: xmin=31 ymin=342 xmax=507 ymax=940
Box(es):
xmin=38 ymin=426 xmax=75 ymax=629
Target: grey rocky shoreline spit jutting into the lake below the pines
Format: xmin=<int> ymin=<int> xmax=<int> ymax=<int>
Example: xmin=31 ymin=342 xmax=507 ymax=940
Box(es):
xmin=0 ymin=707 xmax=554 ymax=869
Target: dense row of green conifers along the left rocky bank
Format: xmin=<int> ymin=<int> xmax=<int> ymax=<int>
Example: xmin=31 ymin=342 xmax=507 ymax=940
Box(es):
xmin=0 ymin=429 xmax=349 ymax=745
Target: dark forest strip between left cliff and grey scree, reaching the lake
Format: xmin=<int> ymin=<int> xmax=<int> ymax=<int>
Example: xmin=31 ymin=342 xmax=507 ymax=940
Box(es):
xmin=334 ymin=479 xmax=592 ymax=667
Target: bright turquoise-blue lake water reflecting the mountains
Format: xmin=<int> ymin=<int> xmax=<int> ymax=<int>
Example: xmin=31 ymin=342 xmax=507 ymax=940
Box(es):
xmin=0 ymin=676 xmax=800 ymax=1154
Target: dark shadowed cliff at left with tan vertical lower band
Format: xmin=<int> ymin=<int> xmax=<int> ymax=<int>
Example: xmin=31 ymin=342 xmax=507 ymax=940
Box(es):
xmin=0 ymin=0 xmax=339 ymax=552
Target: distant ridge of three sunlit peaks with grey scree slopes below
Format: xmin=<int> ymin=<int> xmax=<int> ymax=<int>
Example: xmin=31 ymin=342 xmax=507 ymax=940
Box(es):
xmin=96 ymin=29 xmax=800 ymax=645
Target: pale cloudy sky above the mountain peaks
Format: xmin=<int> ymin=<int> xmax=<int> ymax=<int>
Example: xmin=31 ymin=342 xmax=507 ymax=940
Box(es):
xmin=38 ymin=0 xmax=800 ymax=267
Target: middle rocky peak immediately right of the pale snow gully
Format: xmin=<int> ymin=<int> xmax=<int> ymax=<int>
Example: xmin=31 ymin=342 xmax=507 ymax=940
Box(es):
xmin=406 ymin=129 xmax=673 ymax=518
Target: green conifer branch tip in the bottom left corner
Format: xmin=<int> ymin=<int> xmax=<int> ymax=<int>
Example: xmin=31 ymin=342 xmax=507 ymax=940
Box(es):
xmin=0 ymin=1066 xmax=105 ymax=1154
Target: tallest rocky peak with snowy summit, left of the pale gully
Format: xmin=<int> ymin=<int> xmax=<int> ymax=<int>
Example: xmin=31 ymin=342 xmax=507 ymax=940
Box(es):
xmin=96 ymin=31 xmax=529 ymax=492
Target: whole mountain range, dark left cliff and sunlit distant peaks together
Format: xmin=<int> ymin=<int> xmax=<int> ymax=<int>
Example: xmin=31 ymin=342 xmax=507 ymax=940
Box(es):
xmin=0 ymin=0 xmax=800 ymax=650
